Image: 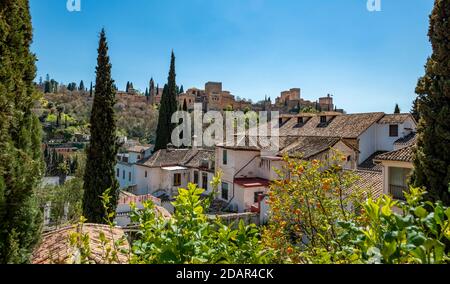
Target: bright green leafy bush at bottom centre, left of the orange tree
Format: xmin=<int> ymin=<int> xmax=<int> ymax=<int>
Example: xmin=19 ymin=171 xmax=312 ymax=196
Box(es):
xmin=128 ymin=184 xmax=271 ymax=264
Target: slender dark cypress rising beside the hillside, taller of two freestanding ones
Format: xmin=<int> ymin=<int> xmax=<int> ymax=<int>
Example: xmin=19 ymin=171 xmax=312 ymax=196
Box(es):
xmin=83 ymin=30 xmax=119 ymax=224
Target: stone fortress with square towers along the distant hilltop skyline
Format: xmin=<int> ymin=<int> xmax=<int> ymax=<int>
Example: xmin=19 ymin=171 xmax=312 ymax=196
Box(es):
xmin=118 ymin=79 xmax=344 ymax=114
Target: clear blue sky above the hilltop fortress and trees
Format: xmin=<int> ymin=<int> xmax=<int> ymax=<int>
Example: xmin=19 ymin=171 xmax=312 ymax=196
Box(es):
xmin=30 ymin=0 xmax=434 ymax=113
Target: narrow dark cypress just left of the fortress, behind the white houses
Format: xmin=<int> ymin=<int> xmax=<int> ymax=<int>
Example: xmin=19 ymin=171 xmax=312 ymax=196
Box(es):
xmin=155 ymin=52 xmax=177 ymax=151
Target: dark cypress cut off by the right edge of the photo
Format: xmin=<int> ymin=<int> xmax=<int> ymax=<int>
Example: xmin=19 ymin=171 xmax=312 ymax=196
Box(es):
xmin=412 ymin=0 xmax=450 ymax=205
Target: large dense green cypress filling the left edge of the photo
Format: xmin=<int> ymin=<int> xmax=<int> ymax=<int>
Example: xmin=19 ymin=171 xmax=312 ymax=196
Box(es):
xmin=0 ymin=0 xmax=44 ymax=264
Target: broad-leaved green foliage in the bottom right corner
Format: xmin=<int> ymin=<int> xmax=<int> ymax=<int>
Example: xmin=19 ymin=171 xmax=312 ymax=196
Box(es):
xmin=340 ymin=188 xmax=450 ymax=264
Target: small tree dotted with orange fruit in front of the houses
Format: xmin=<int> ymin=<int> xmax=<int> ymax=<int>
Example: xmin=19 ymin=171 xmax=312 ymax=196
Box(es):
xmin=263 ymin=154 xmax=364 ymax=263
